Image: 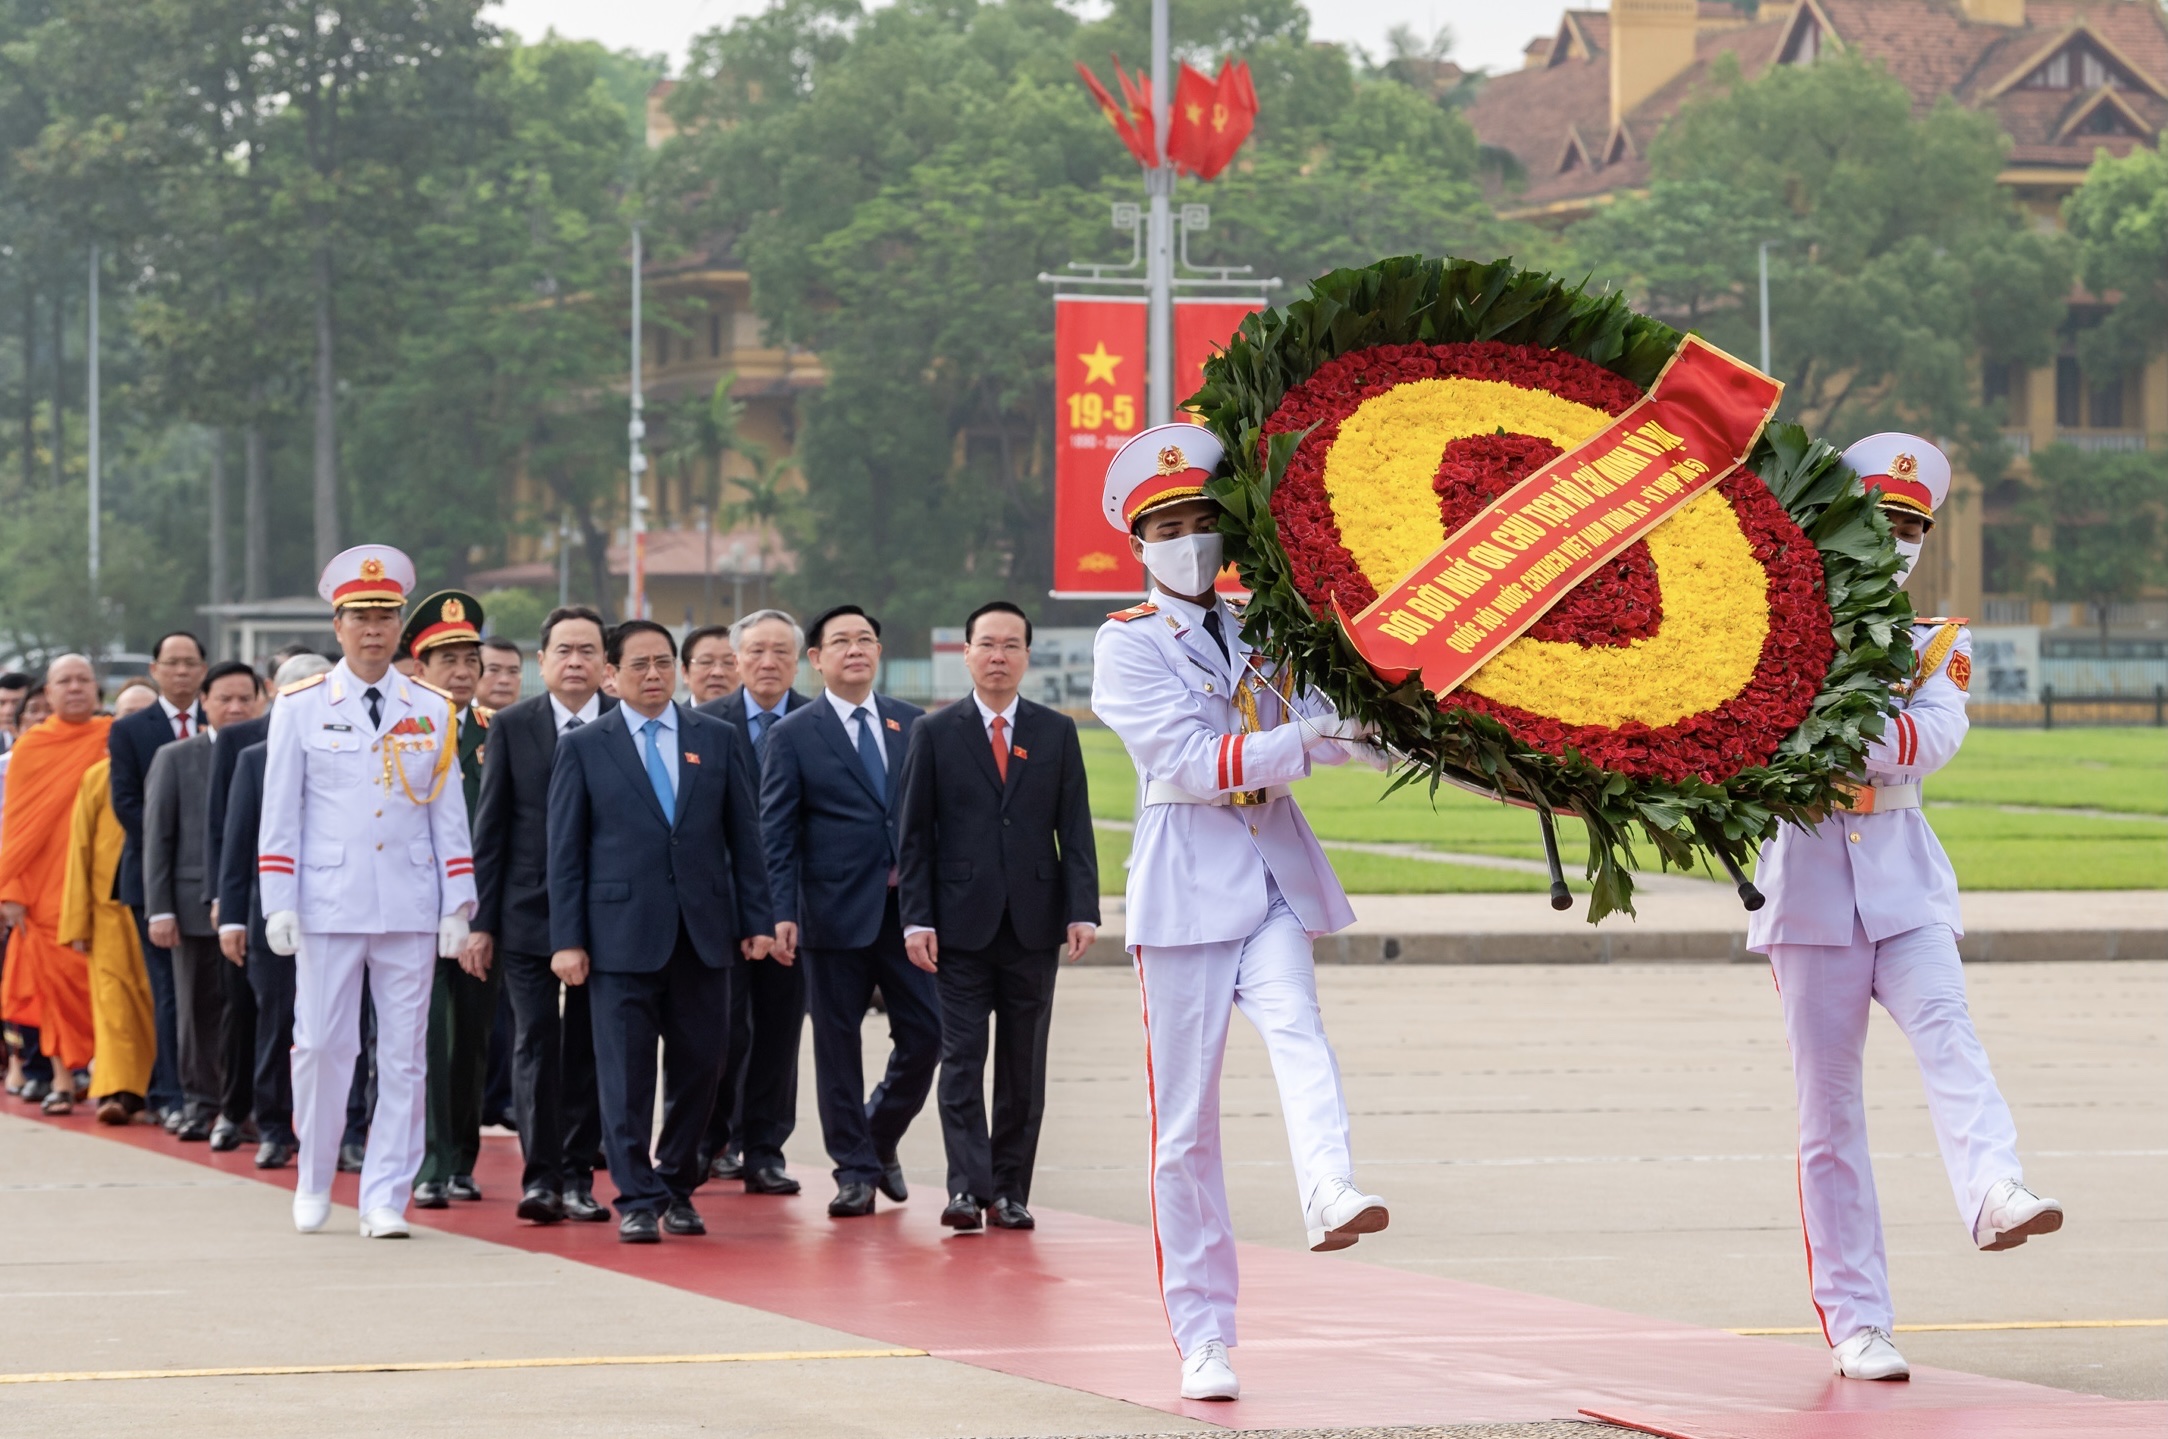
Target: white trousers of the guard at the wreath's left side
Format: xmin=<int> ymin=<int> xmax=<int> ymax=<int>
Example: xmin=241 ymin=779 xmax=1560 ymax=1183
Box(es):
xmin=1136 ymin=889 xmax=1353 ymax=1354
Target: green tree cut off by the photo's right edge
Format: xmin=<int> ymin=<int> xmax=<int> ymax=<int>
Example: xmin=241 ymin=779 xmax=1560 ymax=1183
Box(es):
xmin=2062 ymin=145 xmax=2168 ymax=375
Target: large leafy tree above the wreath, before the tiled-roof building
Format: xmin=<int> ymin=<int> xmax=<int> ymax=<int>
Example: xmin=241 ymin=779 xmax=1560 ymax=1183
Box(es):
xmin=1567 ymin=56 xmax=2070 ymax=461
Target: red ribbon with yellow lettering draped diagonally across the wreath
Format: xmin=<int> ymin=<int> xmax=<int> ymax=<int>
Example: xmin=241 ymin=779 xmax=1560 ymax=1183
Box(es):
xmin=1333 ymin=336 xmax=1784 ymax=696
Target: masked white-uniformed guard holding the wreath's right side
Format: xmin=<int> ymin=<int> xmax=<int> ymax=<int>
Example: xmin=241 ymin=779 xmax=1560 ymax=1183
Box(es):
xmin=1747 ymin=433 xmax=2062 ymax=1378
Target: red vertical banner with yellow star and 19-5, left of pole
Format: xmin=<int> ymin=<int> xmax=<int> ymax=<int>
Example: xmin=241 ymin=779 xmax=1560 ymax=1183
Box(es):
xmin=1054 ymin=295 xmax=1153 ymax=600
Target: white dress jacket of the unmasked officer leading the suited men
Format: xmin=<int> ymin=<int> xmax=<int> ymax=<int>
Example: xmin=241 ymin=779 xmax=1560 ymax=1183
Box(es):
xmin=258 ymin=661 xmax=475 ymax=934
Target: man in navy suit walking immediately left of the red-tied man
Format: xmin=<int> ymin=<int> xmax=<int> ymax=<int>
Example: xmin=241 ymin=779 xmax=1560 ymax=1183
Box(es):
xmin=761 ymin=605 xmax=941 ymax=1218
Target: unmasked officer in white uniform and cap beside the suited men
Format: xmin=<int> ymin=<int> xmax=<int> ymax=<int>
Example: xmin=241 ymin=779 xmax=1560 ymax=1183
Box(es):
xmin=256 ymin=544 xmax=475 ymax=1237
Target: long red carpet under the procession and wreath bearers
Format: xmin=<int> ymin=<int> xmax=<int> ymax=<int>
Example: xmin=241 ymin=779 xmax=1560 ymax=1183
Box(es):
xmin=52 ymin=1116 xmax=2168 ymax=1439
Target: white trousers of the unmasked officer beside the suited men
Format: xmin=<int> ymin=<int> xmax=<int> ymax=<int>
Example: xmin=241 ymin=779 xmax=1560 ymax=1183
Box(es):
xmin=293 ymin=934 xmax=436 ymax=1214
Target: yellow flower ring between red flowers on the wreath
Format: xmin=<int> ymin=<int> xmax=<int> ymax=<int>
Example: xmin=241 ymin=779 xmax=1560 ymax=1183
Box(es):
xmin=1325 ymin=377 xmax=1769 ymax=728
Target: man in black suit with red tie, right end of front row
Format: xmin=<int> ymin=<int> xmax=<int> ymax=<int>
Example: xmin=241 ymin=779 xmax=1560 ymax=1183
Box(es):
xmin=898 ymin=600 xmax=1099 ymax=1231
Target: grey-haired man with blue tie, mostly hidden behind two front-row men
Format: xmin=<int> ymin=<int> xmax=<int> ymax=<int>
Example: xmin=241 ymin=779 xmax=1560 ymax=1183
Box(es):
xmin=683 ymin=609 xmax=811 ymax=1194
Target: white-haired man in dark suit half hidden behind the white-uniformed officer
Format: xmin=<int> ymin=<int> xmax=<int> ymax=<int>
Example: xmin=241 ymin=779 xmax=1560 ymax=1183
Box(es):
xmin=206 ymin=646 xmax=331 ymax=1168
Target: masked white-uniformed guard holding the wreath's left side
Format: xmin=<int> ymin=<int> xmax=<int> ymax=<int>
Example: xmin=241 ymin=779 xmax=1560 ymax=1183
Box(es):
xmin=1093 ymin=425 xmax=1388 ymax=1400
